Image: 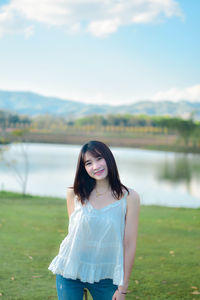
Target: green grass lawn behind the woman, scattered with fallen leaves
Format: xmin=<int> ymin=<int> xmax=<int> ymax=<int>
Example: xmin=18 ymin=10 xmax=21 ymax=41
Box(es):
xmin=0 ymin=192 xmax=200 ymax=300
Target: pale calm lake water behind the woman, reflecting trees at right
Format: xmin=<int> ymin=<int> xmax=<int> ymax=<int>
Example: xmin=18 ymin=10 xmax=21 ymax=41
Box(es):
xmin=0 ymin=144 xmax=200 ymax=208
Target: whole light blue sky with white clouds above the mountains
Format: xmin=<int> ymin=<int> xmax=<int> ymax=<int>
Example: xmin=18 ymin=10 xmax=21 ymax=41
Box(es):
xmin=0 ymin=0 xmax=200 ymax=105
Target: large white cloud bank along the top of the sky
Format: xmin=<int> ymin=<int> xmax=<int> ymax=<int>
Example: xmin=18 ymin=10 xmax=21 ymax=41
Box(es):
xmin=0 ymin=0 xmax=182 ymax=37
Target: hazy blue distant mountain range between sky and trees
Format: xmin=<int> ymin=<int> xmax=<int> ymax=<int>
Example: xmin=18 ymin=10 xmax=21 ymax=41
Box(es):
xmin=0 ymin=91 xmax=200 ymax=120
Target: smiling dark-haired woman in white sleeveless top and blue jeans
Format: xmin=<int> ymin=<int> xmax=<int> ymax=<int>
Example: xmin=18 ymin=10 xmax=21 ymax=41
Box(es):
xmin=49 ymin=141 xmax=140 ymax=300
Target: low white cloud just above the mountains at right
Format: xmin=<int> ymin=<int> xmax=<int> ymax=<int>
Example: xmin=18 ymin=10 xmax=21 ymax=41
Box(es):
xmin=151 ymin=84 xmax=200 ymax=102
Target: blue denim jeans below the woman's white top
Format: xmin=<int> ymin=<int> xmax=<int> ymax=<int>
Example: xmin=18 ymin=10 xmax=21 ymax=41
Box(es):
xmin=56 ymin=274 xmax=118 ymax=300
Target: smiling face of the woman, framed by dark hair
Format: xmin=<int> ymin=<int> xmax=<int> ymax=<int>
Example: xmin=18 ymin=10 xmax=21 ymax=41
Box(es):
xmin=84 ymin=151 xmax=108 ymax=180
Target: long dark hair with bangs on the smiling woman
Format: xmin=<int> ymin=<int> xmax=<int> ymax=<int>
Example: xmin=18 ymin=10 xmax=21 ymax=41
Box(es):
xmin=73 ymin=141 xmax=129 ymax=204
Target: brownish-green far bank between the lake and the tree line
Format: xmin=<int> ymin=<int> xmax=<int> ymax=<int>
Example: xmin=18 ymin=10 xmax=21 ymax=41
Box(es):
xmin=0 ymin=132 xmax=200 ymax=154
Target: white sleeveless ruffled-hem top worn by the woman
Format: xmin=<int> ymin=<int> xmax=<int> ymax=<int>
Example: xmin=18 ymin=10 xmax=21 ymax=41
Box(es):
xmin=48 ymin=192 xmax=128 ymax=285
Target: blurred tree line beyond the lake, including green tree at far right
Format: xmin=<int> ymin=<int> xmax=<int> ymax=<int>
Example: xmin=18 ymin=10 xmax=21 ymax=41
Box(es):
xmin=0 ymin=110 xmax=200 ymax=145
